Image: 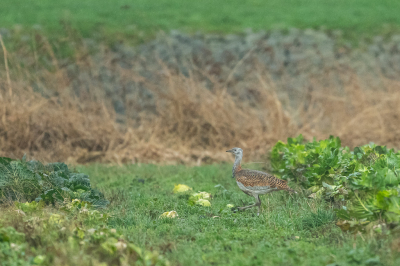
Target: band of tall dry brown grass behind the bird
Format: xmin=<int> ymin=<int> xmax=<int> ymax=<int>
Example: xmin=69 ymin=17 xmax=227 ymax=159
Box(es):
xmin=0 ymin=36 xmax=400 ymax=164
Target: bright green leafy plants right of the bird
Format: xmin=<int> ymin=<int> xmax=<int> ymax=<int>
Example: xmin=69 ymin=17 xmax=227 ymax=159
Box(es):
xmin=272 ymin=135 xmax=400 ymax=222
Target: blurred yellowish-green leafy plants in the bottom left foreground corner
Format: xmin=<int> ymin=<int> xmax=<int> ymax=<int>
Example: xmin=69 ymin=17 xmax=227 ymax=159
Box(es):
xmin=0 ymin=196 xmax=168 ymax=265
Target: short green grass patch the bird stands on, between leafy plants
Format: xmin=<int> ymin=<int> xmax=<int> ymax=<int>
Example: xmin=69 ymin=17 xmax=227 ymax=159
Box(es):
xmin=71 ymin=164 xmax=400 ymax=265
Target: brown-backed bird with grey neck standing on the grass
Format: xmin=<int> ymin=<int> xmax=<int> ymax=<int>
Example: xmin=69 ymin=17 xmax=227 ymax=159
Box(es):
xmin=226 ymin=147 xmax=297 ymax=216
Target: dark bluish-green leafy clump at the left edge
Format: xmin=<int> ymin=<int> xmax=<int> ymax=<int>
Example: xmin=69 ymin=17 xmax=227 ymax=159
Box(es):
xmin=0 ymin=157 xmax=108 ymax=207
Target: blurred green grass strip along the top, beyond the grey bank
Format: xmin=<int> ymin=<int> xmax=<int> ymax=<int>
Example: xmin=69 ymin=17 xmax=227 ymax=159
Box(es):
xmin=0 ymin=0 xmax=400 ymax=41
